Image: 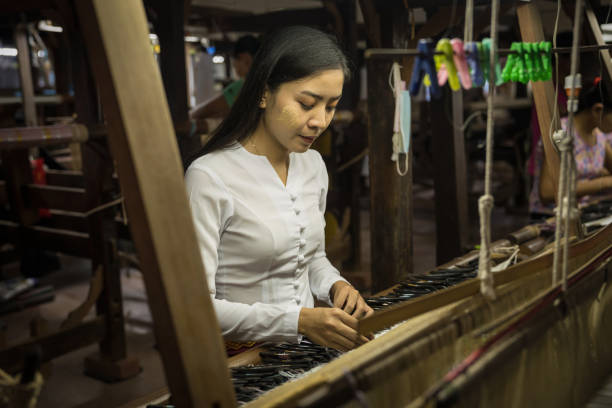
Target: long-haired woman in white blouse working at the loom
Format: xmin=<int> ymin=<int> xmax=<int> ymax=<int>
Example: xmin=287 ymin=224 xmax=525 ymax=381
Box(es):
xmin=186 ymin=27 xmax=373 ymax=350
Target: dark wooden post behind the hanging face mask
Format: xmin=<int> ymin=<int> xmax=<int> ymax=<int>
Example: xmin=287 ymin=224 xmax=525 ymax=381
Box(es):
xmin=364 ymin=1 xmax=412 ymax=292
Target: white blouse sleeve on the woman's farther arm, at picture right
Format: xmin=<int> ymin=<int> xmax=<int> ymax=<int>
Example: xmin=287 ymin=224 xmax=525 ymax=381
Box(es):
xmin=308 ymin=152 xmax=349 ymax=306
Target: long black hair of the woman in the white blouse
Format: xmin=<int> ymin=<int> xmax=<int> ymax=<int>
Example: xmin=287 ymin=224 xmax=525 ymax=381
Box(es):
xmin=191 ymin=26 xmax=350 ymax=161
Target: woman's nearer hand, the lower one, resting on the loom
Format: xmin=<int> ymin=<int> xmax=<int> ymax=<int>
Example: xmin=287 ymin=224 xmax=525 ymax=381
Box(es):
xmin=298 ymin=307 xmax=369 ymax=351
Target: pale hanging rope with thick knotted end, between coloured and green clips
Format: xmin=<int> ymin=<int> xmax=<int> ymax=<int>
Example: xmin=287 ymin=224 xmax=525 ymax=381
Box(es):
xmin=478 ymin=0 xmax=499 ymax=300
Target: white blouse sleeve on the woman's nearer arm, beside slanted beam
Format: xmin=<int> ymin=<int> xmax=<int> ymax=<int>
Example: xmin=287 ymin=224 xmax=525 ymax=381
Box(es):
xmin=185 ymin=167 xmax=300 ymax=341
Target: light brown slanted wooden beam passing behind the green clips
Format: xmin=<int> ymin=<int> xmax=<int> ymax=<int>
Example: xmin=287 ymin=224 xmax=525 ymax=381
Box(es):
xmin=516 ymin=3 xmax=561 ymax=200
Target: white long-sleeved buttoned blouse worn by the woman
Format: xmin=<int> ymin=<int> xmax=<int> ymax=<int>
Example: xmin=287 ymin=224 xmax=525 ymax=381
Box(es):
xmin=185 ymin=143 xmax=344 ymax=341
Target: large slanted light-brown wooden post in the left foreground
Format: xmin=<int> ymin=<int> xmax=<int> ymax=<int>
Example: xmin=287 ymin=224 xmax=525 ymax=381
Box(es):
xmin=75 ymin=0 xmax=236 ymax=407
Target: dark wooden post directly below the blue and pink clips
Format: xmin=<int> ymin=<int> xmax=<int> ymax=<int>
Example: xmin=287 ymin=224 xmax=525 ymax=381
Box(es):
xmin=429 ymin=86 xmax=468 ymax=265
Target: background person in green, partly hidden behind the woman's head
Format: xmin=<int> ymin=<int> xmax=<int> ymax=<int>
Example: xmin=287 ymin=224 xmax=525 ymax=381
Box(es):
xmin=189 ymin=35 xmax=259 ymax=131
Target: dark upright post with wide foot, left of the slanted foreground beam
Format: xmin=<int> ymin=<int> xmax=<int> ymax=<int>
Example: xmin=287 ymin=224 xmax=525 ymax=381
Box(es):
xmin=62 ymin=7 xmax=141 ymax=381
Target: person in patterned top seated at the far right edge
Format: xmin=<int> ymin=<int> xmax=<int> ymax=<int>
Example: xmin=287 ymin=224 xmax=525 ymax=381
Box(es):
xmin=529 ymin=78 xmax=612 ymax=218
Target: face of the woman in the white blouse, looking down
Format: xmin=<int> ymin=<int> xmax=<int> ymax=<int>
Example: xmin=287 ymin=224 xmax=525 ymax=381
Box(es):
xmin=260 ymin=69 xmax=344 ymax=153
